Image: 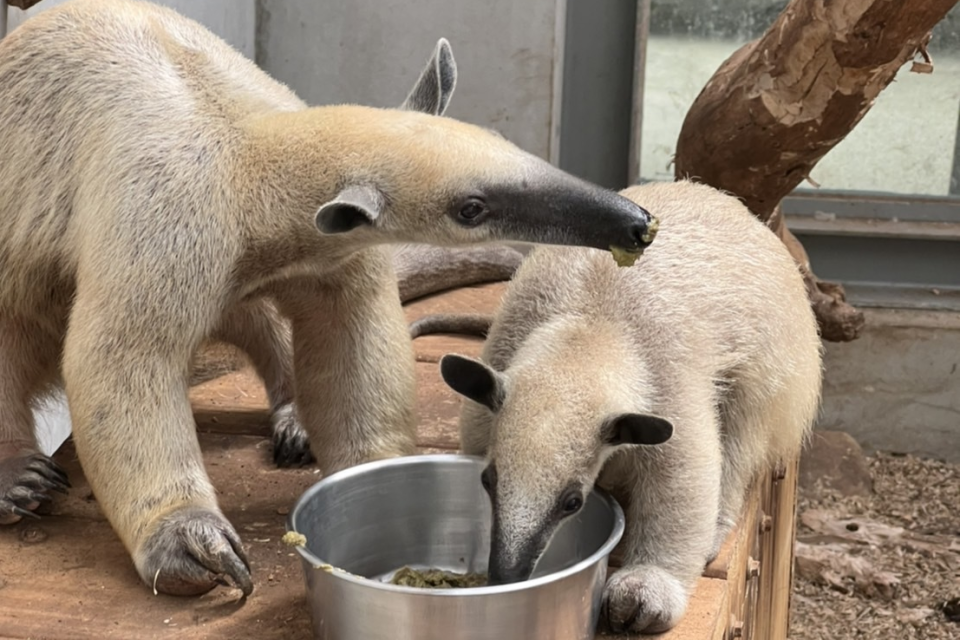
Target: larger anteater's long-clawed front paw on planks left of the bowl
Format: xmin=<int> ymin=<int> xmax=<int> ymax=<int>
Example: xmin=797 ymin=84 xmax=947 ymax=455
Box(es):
xmin=137 ymin=507 xmax=253 ymax=596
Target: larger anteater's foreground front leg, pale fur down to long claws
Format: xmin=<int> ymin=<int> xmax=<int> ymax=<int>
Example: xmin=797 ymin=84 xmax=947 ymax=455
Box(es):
xmin=63 ymin=270 xmax=253 ymax=595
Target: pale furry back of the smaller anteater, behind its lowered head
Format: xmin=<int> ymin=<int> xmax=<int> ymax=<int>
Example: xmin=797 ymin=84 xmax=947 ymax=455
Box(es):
xmin=488 ymin=182 xmax=820 ymax=456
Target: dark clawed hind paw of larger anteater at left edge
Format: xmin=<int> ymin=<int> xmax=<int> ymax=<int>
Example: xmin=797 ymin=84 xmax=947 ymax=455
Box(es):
xmin=0 ymin=452 xmax=70 ymax=524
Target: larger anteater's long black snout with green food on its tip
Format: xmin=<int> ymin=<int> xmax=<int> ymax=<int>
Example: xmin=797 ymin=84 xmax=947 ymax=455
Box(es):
xmin=491 ymin=172 xmax=658 ymax=252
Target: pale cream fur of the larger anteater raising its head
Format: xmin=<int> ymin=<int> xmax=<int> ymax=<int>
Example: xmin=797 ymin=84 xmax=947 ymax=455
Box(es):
xmin=0 ymin=0 xmax=641 ymax=594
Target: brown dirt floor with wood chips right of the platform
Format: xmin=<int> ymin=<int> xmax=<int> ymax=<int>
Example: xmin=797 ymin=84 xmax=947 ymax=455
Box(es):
xmin=790 ymin=453 xmax=960 ymax=640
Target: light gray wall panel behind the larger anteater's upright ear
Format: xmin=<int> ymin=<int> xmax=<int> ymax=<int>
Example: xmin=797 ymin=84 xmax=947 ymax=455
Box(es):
xmin=257 ymin=0 xmax=565 ymax=158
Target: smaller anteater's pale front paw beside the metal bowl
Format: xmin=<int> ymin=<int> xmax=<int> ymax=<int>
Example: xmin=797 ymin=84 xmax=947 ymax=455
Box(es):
xmin=600 ymin=565 xmax=687 ymax=633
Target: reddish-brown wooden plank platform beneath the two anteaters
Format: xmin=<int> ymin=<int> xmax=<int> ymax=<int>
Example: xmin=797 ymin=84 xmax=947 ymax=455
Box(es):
xmin=0 ymin=285 xmax=795 ymax=640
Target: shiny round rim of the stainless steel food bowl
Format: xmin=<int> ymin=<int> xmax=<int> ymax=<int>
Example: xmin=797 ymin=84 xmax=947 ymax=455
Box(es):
xmin=287 ymin=453 xmax=626 ymax=598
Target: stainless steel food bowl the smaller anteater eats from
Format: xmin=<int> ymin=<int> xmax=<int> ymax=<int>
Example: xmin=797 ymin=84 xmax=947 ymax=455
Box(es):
xmin=287 ymin=455 xmax=624 ymax=640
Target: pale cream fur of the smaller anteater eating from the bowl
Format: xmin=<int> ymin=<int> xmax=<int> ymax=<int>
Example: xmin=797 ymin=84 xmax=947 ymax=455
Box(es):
xmin=460 ymin=182 xmax=821 ymax=632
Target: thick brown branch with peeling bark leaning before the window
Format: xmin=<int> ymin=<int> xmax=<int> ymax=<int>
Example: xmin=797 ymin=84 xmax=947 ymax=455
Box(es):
xmin=675 ymin=0 xmax=957 ymax=341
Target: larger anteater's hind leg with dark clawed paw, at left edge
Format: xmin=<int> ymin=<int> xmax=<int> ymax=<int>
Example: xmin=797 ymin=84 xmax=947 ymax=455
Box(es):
xmin=0 ymin=315 xmax=70 ymax=524
